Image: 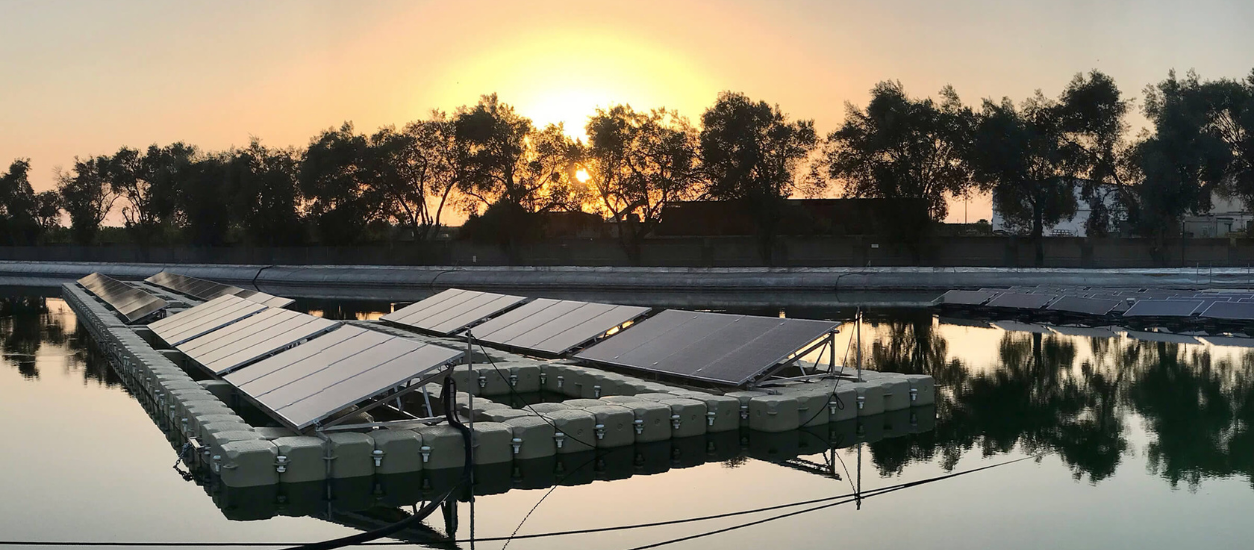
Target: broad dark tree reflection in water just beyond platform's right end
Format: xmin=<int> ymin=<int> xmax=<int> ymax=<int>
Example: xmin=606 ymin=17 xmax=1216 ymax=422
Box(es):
xmin=872 ymin=323 xmax=1127 ymax=481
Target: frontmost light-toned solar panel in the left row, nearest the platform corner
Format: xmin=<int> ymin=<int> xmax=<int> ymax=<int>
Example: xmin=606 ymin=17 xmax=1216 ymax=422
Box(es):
xmin=224 ymin=326 xmax=463 ymax=431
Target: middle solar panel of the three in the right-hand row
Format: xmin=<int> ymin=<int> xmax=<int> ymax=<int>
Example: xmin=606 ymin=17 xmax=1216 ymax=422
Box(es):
xmin=474 ymin=298 xmax=648 ymax=355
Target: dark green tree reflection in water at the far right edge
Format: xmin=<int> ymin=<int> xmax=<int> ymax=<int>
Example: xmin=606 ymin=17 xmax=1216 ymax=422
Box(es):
xmin=1124 ymin=342 xmax=1254 ymax=489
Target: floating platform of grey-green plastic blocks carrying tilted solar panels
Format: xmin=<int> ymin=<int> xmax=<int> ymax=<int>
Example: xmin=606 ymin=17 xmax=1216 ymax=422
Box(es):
xmin=63 ymin=275 xmax=935 ymax=501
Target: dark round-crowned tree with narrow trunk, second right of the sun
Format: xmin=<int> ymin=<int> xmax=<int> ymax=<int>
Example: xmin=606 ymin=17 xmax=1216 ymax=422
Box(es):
xmin=700 ymin=91 xmax=818 ymax=264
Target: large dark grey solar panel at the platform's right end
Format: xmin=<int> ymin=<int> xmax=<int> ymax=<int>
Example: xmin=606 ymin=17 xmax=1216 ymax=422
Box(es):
xmin=576 ymin=309 xmax=839 ymax=386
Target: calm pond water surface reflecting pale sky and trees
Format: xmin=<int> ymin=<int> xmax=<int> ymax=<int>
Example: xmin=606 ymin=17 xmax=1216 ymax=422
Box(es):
xmin=0 ymin=298 xmax=1254 ymax=549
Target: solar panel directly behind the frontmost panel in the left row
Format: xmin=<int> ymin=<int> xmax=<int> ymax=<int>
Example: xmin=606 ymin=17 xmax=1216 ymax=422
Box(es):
xmin=176 ymin=308 xmax=340 ymax=375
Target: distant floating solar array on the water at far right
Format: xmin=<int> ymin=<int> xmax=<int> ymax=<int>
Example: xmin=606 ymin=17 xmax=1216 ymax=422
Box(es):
xmin=937 ymin=287 xmax=1254 ymax=321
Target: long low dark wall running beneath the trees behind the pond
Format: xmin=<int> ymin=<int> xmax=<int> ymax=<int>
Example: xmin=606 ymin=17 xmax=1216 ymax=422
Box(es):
xmin=7 ymin=237 xmax=1254 ymax=268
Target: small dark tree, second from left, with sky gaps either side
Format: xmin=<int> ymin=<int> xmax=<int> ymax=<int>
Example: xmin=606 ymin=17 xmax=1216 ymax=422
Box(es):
xmin=56 ymin=155 xmax=117 ymax=244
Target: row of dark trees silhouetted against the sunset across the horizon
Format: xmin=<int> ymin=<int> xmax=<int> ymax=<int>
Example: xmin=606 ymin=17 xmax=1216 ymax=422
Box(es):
xmin=0 ymin=71 xmax=1254 ymax=261
